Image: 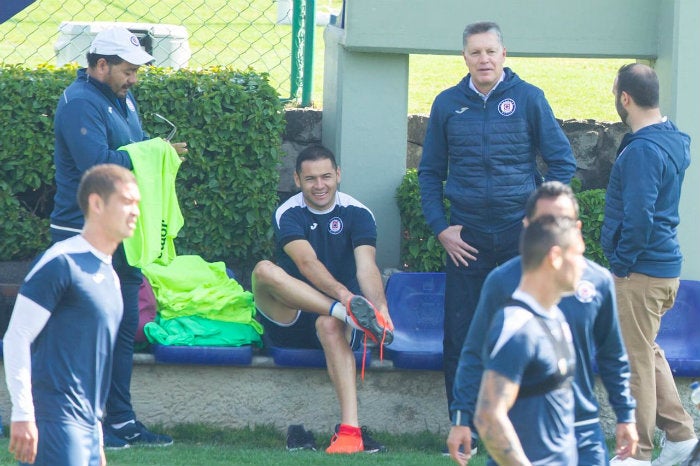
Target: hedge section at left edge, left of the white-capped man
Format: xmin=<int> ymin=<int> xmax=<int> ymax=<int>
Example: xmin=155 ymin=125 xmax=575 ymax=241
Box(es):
xmin=0 ymin=65 xmax=75 ymax=260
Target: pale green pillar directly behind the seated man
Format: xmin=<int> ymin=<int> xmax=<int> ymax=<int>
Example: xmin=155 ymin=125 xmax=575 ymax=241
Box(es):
xmin=323 ymin=26 xmax=408 ymax=268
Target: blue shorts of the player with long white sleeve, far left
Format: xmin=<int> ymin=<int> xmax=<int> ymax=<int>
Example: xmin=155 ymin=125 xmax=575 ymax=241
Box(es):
xmin=20 ymin=419 xmax=100 ymax=466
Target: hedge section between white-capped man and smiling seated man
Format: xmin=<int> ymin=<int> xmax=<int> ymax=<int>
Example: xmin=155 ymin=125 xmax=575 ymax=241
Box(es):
xmin=134 ymin=67 xmax=285 ymax=271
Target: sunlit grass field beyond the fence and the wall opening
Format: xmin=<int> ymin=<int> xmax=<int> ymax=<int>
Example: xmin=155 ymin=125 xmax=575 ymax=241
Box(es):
xmin=0 ymin=0 xmax=629 ymax=121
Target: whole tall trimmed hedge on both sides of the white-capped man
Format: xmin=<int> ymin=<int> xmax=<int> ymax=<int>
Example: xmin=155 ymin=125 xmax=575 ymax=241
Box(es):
xmin=0 ymin=62 xmax=285 ymax=271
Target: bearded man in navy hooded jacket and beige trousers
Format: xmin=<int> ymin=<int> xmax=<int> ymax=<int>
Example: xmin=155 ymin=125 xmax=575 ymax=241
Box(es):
xmin=600 ymin=63 xmax=698 ymax=466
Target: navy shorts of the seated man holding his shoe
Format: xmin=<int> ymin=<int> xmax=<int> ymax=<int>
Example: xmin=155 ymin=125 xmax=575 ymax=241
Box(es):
xmin=257 ymin=309 xmax=362 ymax=350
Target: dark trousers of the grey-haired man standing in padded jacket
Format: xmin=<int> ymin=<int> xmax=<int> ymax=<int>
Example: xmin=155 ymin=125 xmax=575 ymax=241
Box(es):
xmin=442 ymin=223 xmax=522 ymax=416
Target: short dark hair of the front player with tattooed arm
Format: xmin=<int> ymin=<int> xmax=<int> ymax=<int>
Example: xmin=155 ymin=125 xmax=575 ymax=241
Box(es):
xmin=520 ymin=215 xmax=580 ymax=271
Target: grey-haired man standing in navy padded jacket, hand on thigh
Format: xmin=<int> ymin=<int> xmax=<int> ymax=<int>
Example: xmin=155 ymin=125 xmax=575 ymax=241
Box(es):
xmin=418 ymin=22 xmax=576 ymax=430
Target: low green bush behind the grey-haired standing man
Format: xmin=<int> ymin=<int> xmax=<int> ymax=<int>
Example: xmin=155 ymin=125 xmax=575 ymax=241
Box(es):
xmin=396 ymin=168 xmax=608 ymax=272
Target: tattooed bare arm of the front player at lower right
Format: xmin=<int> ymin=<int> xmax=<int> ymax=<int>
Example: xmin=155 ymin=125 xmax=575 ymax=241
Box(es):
xmin=474 ymin=370 xmax=530 ymax=466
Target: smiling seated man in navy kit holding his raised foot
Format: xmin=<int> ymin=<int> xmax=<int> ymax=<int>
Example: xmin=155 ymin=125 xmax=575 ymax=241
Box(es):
xmin=252 ymin=145 xmax=393 ymax=453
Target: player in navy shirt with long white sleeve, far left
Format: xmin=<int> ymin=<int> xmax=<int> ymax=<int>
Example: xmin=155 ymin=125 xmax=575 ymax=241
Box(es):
xmin=3 ymin=164 xmax=140 ymax=466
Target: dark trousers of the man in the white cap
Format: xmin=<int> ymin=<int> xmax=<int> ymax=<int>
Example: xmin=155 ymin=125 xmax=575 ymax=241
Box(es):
xmin=51 ymin=228 xmax=142 ymax=424
